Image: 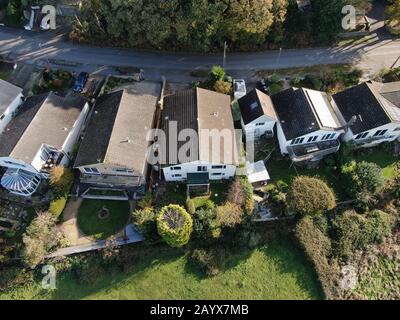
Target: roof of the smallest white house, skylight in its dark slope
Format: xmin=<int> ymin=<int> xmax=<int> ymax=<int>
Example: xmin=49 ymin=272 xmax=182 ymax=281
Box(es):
xmin=238 ymin=89 xmax=276 ymax=125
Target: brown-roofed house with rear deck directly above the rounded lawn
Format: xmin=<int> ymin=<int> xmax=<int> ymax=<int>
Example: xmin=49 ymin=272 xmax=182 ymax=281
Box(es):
xmin=74 ymin=81 xmax=161 ymax=200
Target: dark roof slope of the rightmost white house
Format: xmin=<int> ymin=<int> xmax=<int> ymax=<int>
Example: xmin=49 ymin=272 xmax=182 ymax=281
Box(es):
xmin=333 ymin=82 xmax=391 ymax=134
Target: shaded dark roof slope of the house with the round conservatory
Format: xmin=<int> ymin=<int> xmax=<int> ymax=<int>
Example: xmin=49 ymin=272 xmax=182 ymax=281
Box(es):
xmin=0 ymin=93 xmax=48 ymax=157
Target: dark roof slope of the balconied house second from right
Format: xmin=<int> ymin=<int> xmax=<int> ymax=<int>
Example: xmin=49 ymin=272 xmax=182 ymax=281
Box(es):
xmin=271 ymin=88 xmax=321 ymax=140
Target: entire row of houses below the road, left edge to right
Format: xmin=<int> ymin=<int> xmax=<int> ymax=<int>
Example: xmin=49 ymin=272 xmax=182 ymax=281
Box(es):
xmin=0 ymin=76 xmax=400 ymax=198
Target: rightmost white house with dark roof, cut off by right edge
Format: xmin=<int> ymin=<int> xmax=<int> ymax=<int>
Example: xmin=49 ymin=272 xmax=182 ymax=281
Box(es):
xmin=333 ymin=81 xmax=400 ymax=147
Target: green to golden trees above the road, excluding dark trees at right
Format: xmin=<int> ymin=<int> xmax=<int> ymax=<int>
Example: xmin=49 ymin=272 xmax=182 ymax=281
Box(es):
xmin=72 ymin=0 xmax=288 ymax=51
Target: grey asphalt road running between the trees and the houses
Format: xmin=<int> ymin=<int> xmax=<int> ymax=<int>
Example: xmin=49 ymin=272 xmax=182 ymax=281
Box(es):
xmin=0 ymin=27 xmax=400 ymax=78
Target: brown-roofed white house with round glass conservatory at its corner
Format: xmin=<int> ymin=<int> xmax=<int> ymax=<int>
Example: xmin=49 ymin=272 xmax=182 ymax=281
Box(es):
xmin=0 ymin=93 xmax=89 ymax=196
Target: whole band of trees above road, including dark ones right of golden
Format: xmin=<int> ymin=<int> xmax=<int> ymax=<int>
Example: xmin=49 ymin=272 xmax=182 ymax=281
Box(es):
xmin=71 ymin=0 xmax=343 ymax=52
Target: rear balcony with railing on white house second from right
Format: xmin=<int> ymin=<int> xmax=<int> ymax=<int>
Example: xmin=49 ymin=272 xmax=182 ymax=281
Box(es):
xmin=288 ymin=140 xmax=340 ymax=162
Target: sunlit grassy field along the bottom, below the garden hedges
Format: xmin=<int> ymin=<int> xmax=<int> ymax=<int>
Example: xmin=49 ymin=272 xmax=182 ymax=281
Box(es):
xmin=0 ymin=239 xmax=322 ymax=300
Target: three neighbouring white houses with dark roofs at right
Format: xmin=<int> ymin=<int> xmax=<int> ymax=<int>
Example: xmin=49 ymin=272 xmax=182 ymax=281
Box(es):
xmin=238 ymin=81 xmax=400 ymax=162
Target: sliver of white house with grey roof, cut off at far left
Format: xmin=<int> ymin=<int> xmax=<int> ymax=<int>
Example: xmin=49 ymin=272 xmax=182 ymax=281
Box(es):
xmin=0 ymin=79 xmax=23 ymax=134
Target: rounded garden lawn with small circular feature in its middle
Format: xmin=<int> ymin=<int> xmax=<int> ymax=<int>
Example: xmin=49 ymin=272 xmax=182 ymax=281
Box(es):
xmin=78 ymin=200 xmax=130 ymax=239
